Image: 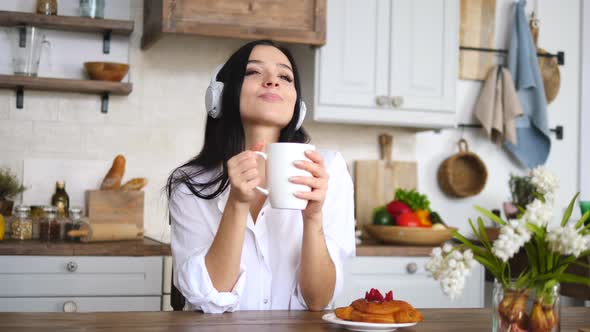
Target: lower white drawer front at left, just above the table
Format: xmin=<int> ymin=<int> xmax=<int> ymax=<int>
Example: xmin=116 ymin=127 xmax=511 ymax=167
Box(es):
xmin=0 ymin=296 xmax=161 ymax=312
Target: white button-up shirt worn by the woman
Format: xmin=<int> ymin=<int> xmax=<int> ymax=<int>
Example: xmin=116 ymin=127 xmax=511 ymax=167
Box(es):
xmin=169 ymin=151 xmax=355 ymax=313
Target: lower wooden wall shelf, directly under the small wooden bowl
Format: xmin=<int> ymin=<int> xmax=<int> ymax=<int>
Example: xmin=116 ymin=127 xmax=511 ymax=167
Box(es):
xmin=0 ymin=75 xmax=133 ymax=96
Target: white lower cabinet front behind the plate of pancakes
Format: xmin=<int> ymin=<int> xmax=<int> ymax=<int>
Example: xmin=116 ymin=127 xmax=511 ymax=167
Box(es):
xmin=336 ymin=256 xmax=484 ymax=308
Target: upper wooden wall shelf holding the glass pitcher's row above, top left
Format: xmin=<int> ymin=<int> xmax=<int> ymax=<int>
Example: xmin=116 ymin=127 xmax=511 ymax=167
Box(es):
xmin=0 ymin=10 xmax=134 ymax=36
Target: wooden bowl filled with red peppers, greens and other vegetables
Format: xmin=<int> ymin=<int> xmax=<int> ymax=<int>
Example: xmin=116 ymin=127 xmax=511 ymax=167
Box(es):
xmin=365 ymin=189 xmax=456 ymax=246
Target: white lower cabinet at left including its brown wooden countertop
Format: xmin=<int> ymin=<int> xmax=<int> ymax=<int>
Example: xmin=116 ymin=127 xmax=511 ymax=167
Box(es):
xmin=0 ymin=238 xmax=171 ymax=312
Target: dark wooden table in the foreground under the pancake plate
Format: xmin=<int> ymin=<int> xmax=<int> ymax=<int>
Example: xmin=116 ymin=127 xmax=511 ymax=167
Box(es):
xmin=0 ymin=307 xmax=590 ymax=332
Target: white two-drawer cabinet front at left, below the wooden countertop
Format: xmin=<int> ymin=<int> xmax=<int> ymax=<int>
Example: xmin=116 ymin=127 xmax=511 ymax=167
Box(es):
xmin=0 ymin=256 xmax=163 ymax=312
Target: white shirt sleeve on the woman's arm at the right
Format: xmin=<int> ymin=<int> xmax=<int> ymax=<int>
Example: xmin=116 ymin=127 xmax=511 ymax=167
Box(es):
xmin=295 ymin=152 xmax=356 ymax=309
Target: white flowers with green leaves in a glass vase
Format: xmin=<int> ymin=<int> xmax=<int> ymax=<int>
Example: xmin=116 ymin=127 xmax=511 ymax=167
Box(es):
xmin=426 ymin=167 xmax=590 ymax=332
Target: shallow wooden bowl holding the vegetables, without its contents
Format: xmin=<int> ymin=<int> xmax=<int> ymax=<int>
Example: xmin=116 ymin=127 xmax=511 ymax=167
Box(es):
xmin=365 ymin=225 xmax=456 ymax=246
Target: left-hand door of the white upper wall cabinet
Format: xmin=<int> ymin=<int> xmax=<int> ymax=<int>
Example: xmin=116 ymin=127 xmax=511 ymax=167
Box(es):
xmin=317 ymin=0 xmax=390 ymax=107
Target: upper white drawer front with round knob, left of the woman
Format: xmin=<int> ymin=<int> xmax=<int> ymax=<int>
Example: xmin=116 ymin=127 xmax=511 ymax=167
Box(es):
xmin=0 ymin=256 xmax=162 ymax=297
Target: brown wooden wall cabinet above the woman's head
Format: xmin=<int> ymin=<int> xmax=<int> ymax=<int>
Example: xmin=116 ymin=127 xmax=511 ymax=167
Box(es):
xmin=141 ymin=0 xmax=326 ymax=49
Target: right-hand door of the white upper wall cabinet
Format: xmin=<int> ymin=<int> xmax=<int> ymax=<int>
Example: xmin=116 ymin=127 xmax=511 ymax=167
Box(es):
xmin=389 ymin=0 xmax=459 ymax=112
